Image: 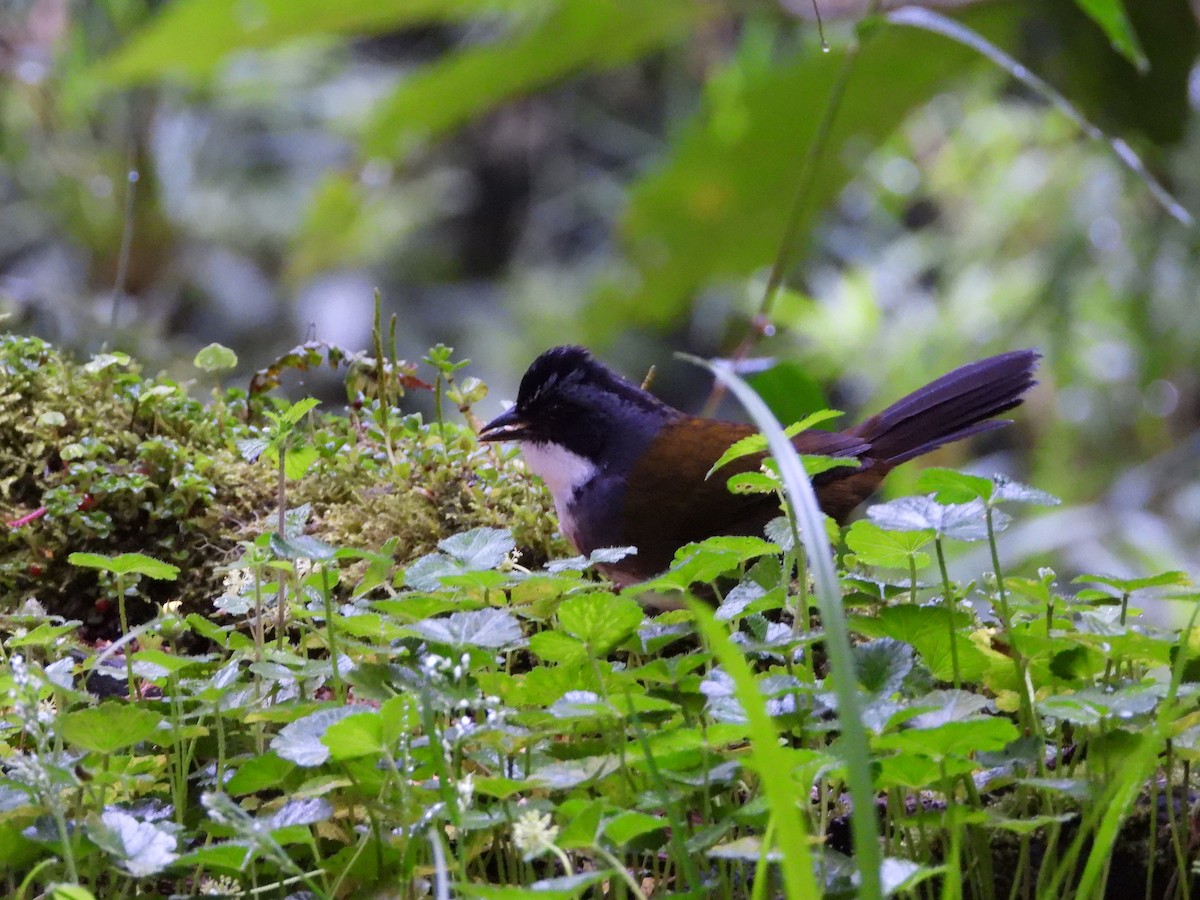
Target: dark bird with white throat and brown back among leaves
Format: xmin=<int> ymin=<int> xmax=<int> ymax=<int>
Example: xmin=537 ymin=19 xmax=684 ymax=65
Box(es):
xmin=479 ymin=346 xmax=1040 ymax=587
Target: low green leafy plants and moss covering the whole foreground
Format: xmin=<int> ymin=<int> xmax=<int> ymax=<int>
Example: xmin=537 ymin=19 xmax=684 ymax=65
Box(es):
xmin=0 ymin=337 xmax=1200 ymax=898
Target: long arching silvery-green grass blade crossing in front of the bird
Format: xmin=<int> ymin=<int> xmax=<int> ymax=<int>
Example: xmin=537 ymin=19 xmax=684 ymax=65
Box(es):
xmin=685 ymin=356 xmax=883 ymax=900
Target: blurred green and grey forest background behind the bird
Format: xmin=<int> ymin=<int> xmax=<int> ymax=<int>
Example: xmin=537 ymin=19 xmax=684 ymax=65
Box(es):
xmin=0 ymin=0 xmax=1200 ymax=575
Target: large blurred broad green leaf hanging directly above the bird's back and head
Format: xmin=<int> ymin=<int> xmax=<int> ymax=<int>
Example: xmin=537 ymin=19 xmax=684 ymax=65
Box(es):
xmin=586 ymin=6 xmax=1016 ymax=340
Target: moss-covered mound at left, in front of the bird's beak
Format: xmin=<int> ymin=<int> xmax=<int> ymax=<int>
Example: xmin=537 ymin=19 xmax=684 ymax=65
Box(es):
xmin=0 ymin=335 xmax=563 ymax=635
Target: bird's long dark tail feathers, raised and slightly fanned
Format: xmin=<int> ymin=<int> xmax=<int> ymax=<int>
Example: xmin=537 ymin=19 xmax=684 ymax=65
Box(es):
xmin=854 ymin=350 xmax=1042 ymax=468
